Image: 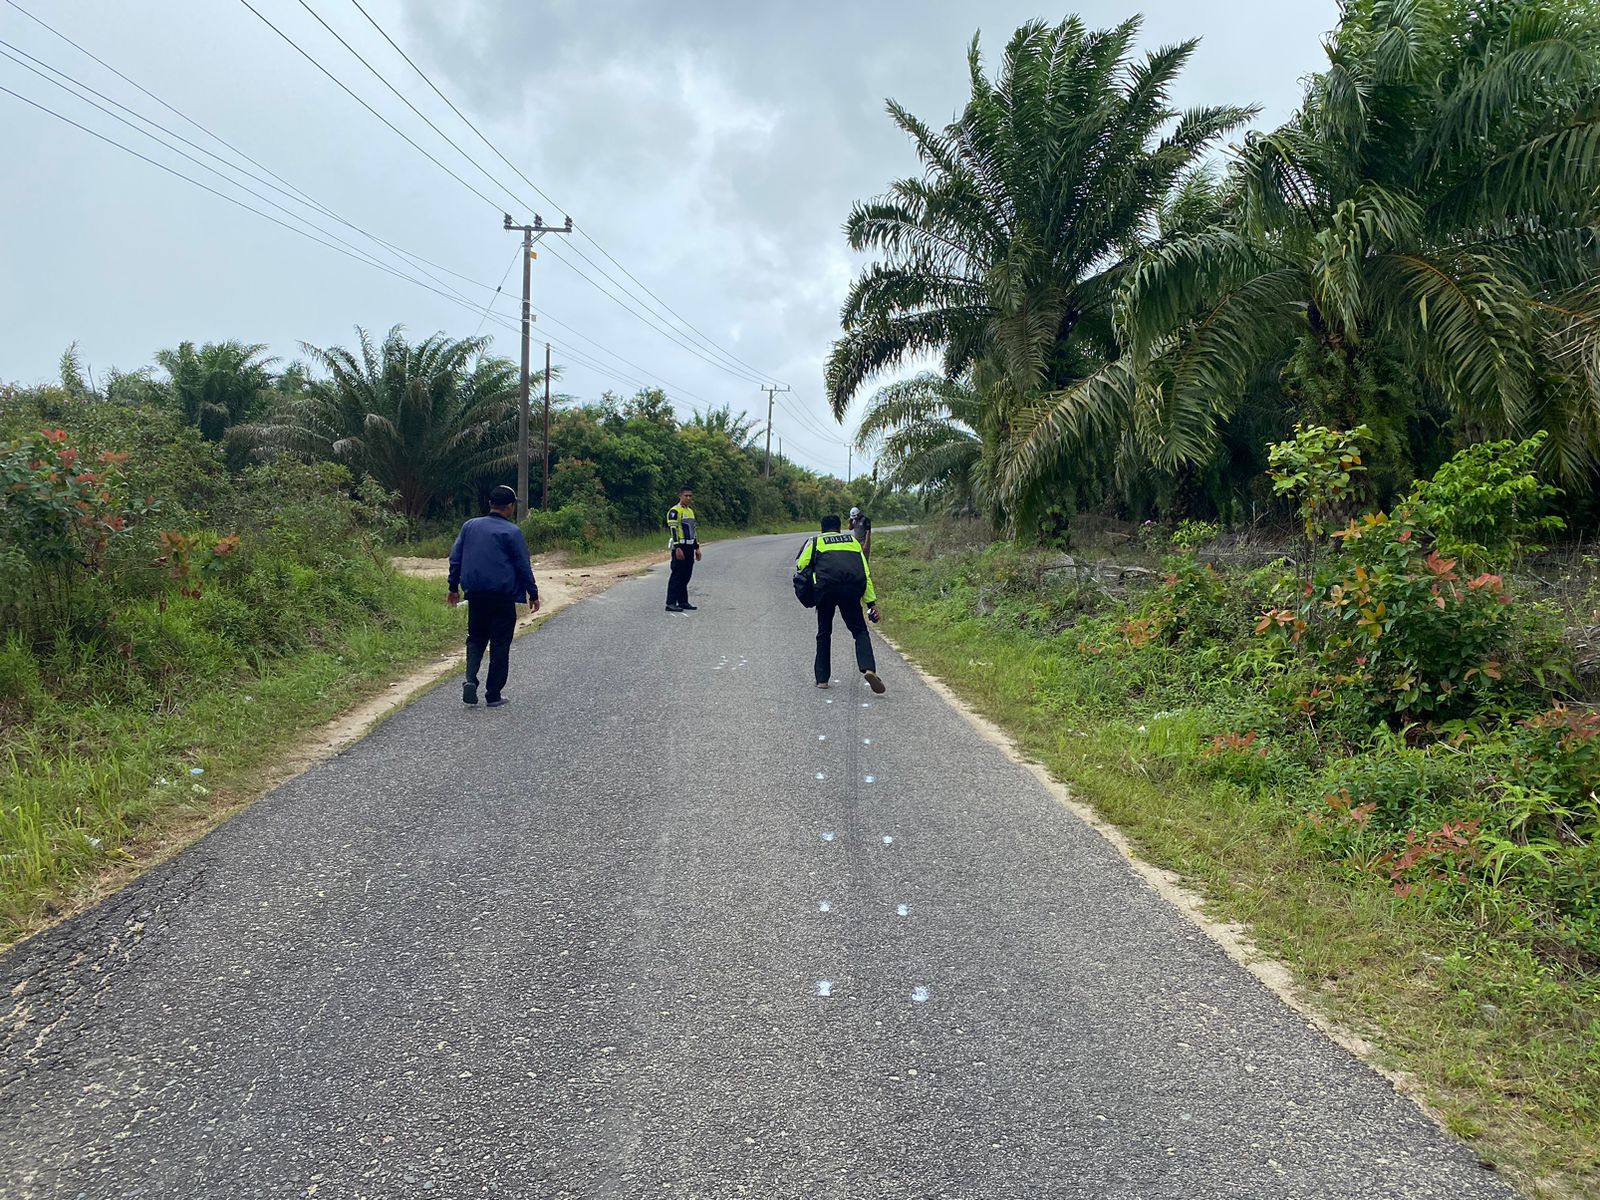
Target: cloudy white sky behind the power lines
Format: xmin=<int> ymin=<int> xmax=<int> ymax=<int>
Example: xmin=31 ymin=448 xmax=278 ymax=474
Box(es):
xmin=0 ymin=0 xmax=1336 ymax=475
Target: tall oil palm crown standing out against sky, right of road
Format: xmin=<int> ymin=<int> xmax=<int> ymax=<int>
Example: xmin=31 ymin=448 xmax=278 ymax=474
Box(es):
xmin=827 ymin=18 xmax=1250 ymax=521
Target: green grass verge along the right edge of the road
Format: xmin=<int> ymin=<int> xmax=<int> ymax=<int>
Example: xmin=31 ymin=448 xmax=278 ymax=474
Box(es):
xmin=872 ymin=534 xmax=1600 ymax=1197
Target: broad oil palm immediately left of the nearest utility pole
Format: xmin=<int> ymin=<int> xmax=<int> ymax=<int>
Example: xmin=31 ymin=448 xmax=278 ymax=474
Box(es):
xmin=254 ymin=325 xmax=517 ymax=518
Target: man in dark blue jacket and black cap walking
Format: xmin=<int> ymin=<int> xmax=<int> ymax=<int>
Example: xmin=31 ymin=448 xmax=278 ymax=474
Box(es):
xmin=450 ymin=483 xmax=539 ymax=709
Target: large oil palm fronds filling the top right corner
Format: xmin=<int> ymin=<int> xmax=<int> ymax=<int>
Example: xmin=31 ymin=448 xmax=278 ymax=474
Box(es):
xmin=1006 ymin=0 xmax=1600 ymax=490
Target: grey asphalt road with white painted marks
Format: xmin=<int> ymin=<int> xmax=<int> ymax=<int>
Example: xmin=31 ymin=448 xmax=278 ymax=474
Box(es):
xmin=0 ymin=538 xmax=1512 ymax=1200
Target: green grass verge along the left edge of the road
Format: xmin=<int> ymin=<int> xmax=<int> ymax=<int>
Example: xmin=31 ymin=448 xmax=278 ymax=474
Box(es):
xmin=0 ymin=576 xmax=462 ymax=944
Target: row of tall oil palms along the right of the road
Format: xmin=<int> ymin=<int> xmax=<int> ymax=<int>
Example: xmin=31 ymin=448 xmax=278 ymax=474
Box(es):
xmin=827 ymin=0 xmax=1600 ymax=530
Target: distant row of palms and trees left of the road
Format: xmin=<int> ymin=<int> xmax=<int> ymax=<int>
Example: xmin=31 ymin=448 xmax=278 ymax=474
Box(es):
xmin=0 ymin=326 xmax=904 ymax=541
